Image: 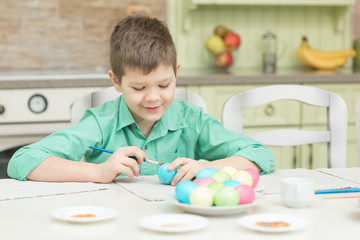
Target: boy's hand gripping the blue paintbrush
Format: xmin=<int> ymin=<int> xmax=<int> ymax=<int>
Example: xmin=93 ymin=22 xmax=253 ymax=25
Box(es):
xmin=98 ymin=146 xmax=147 ymax=183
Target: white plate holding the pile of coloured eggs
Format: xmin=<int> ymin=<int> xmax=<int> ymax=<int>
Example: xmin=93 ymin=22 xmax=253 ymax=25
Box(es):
xmin=168 ymin=192 xmax=263 ymax=216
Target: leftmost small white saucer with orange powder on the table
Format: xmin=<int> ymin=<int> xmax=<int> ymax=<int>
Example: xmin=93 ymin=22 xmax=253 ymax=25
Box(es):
xmin=51 ymin=206 xmax=117 ymax=223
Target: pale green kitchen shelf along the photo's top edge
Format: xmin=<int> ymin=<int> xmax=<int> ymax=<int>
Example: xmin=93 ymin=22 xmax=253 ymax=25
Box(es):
xmin=191 ymin=0 xmax=355 ymax=6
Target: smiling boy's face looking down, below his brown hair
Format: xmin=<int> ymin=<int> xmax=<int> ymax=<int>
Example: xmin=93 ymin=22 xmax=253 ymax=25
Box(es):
xmin=109 ymin=65 xmax=176 ymax=126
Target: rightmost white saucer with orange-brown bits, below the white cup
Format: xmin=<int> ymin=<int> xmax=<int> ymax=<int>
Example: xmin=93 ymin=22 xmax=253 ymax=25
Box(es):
xmin=238 ymin=213 xmax=308 ymax=232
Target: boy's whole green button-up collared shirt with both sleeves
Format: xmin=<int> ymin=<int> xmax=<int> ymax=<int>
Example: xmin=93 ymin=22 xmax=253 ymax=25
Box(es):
xmin=8 ymin=95 xmax=275 ymax=180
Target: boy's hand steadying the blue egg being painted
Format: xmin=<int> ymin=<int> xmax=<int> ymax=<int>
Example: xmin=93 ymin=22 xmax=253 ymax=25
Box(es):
xmin=168 ymin=157 xmax=205 ymax=186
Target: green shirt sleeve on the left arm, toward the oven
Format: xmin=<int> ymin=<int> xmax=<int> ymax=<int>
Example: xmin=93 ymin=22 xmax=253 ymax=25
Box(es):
xmin=8 ymin=111 xmax=103 ymax=180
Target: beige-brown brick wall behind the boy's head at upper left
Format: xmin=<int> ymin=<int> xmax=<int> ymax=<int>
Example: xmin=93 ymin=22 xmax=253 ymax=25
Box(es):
xmin=0 ymin=0 xmax=165 ymax=70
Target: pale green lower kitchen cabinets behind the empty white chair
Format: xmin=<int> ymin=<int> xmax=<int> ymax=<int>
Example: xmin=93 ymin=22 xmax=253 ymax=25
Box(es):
xmin=182 ymin=83 xmax=360 ymax=168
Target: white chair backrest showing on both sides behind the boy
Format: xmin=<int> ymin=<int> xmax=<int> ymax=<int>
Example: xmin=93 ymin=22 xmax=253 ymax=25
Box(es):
xmin=71 ymin=87 xmax=207 ymax=125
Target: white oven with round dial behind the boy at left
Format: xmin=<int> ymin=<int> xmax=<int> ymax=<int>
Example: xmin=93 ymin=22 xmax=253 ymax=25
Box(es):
xmin=0 ymin=84 xmax=101 ymax=178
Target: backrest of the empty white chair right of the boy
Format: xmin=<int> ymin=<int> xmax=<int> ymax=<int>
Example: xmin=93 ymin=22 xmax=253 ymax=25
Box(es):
xmin=222 ymin=85 xmax=348 ymax=167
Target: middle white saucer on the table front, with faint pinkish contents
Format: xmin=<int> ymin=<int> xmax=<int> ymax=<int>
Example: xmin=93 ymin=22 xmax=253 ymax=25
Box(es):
xmin=139 ymin=213 xmax=209 ymax=232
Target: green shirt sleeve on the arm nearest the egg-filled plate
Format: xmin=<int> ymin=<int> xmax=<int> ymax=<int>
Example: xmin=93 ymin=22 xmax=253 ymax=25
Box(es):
xmin=196 ymin=113 xmax=275 ymax=174
